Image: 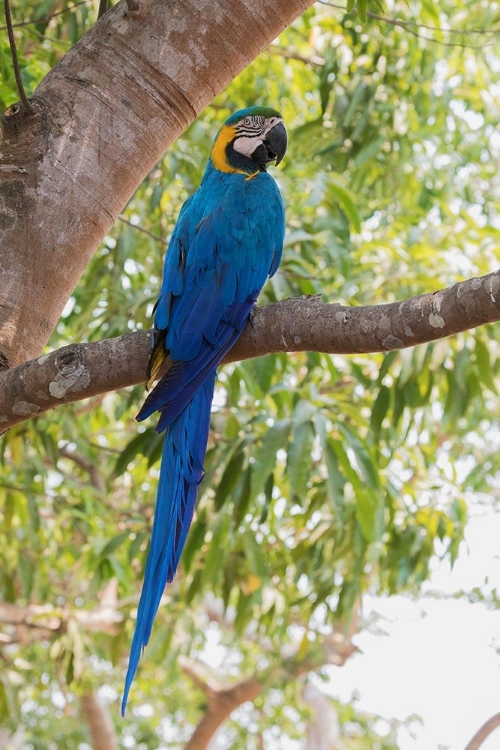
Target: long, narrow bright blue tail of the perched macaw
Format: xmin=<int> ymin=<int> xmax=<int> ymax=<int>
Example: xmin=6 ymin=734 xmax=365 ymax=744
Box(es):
xmin=122 ymin=371 xmax=215 ymax=716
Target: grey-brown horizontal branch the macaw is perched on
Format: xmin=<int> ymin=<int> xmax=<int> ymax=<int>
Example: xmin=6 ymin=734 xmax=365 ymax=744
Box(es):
xmin=0 ymin=271 xmax=500 ymax=431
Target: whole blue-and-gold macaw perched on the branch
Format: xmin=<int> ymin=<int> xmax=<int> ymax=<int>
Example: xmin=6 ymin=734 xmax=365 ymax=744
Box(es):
xmin=122 ymin=107 xmax=287 ymax=714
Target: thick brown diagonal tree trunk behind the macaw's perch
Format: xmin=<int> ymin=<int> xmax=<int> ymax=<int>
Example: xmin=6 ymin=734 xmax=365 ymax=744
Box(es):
xmin=0 ymin=0 xmax=312 ymax=369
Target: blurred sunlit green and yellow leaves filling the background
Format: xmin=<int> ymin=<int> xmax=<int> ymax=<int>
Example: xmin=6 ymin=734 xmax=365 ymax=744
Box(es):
xmin=0 ymin=0 xmax=500 ymax=750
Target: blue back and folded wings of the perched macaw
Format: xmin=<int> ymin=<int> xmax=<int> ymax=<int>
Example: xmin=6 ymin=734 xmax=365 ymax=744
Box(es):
xmin=138 ymin=160 xmax=285 ymax=431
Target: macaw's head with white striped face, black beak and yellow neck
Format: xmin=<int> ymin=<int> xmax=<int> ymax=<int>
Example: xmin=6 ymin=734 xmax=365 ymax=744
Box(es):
xmin=211 ymin=107 xmax=287 ymax=175
